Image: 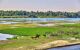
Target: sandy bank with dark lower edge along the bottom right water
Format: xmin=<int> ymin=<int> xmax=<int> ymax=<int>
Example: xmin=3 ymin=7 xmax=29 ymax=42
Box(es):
xmin=35 ymin=40 xmax=80 ymax=50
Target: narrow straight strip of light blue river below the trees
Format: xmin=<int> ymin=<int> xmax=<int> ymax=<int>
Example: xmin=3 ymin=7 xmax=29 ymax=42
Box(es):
xmin=0 ymin=18 xmax=80 ymax=21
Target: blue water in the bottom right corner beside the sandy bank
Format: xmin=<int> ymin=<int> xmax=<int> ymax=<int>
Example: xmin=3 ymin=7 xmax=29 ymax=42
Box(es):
xmin=48 ymin=45 xmax=80 ymax=50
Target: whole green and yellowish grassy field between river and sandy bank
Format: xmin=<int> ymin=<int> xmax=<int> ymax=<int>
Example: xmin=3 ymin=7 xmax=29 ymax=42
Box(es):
xmin=0 ymin=24 xmax=80 ymax=50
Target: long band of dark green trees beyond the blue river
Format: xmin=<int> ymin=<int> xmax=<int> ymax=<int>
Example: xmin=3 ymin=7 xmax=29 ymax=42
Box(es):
xmin=0 ymin=10 xmax=80 ymax=18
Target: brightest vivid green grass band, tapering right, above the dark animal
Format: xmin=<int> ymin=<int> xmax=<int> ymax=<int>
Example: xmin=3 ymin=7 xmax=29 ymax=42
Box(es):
xmin=0 ymin=27 xmax=60 ymax=35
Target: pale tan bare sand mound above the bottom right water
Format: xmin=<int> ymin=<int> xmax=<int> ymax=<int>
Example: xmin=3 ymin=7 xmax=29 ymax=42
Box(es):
xmin=36 ymin=40 xmax=69 ymax=49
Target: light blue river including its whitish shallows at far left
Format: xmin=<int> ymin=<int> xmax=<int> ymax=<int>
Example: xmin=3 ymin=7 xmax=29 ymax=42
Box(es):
xmin=0 ymin=18 xmax=80 ymax=24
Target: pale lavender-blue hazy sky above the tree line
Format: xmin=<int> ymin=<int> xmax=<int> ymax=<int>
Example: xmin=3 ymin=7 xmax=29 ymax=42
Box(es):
xmin=0 ymin=0 xmax=80 ymax=12
